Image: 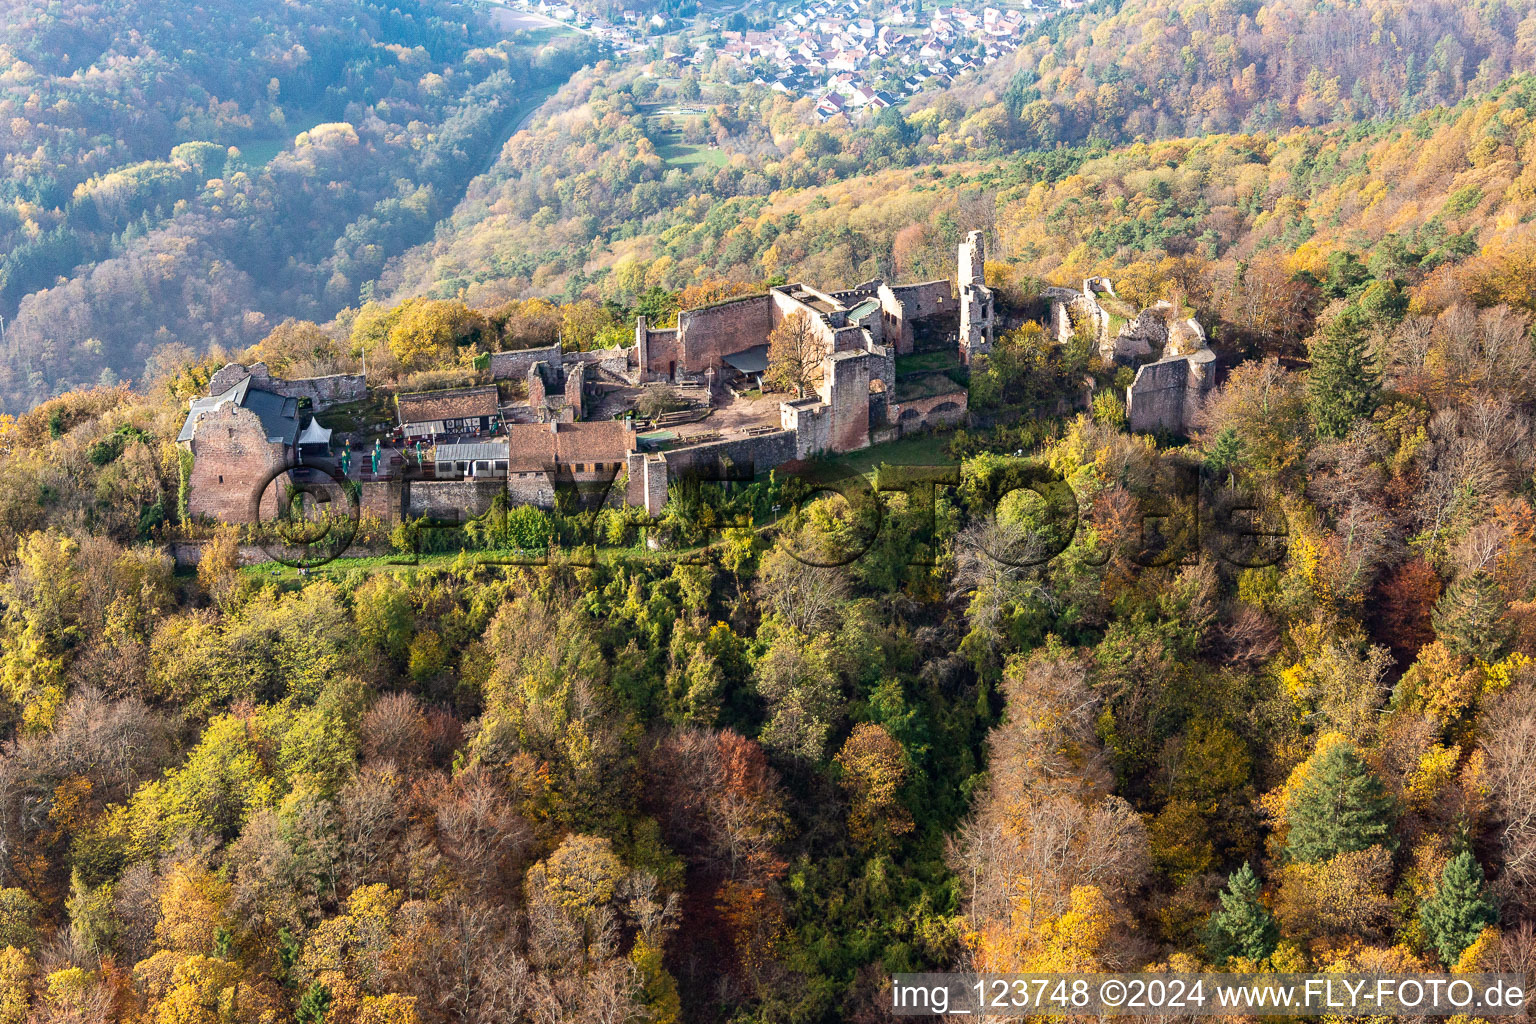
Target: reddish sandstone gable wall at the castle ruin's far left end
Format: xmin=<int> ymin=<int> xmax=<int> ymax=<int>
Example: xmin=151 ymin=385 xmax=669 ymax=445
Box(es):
xmin=187 ymin=404 xmax=289 ymax=524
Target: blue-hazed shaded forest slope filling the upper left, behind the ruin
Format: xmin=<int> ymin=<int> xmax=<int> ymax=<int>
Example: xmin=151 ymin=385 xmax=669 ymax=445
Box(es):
xmin=0 ymin=0 xmax=596 ymax=410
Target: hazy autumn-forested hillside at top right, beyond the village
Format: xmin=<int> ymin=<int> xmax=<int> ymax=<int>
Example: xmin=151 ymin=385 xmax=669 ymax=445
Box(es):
xmin=917 ymin=0 xmax=1536 ymax=149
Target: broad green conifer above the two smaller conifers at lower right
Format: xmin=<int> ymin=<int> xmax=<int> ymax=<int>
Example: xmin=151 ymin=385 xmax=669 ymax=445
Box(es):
xmin=1286 ymin=743 xmax=1396 ymax=864
